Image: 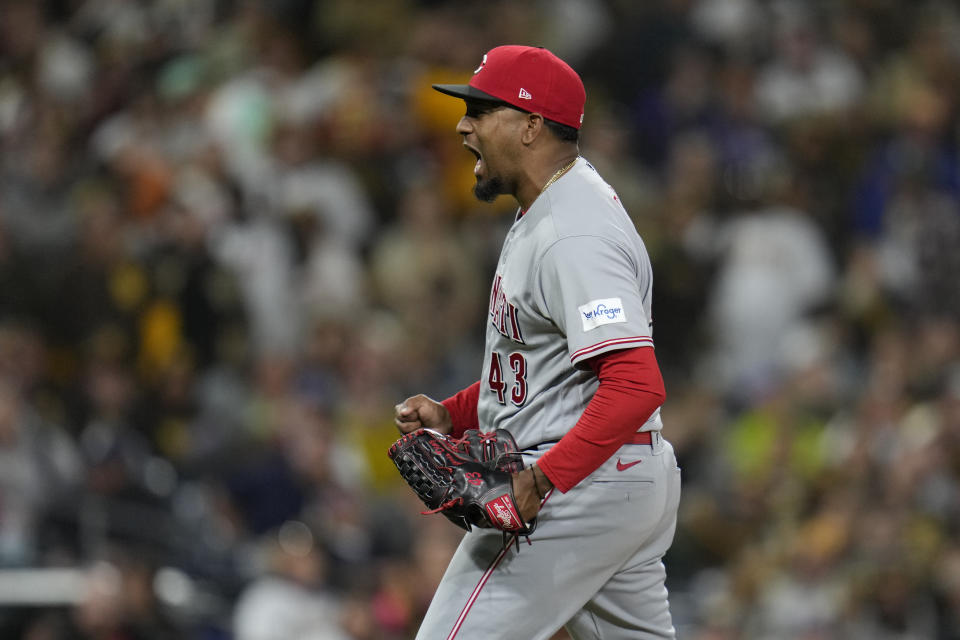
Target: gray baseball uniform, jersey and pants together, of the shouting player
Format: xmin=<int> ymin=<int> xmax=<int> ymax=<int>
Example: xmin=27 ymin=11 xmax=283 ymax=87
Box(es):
xmin=417 ymin=158 xmax=680 ymax=640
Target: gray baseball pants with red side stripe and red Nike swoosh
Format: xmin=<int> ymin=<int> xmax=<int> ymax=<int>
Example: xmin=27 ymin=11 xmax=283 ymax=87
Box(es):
xmin=417 ymin=433 xmax=680 ymax=640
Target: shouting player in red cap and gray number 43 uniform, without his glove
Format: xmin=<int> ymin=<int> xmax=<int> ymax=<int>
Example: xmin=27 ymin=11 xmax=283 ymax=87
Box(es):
xmin=396 ymin=46 xmax=680 ymax=640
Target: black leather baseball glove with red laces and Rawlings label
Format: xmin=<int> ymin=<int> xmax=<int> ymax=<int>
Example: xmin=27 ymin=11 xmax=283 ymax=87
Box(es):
xmin=388 ymin=429 xmax=536 ymax=535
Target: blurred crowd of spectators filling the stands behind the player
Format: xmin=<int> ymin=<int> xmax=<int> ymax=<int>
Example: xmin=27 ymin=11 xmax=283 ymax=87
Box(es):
xmin=0 ymin=0 xmax=960 ymax=640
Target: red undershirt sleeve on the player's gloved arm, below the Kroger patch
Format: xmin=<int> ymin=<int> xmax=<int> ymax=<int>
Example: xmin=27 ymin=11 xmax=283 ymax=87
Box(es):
xmin=537 ymin=347 xmax=666 ymax=493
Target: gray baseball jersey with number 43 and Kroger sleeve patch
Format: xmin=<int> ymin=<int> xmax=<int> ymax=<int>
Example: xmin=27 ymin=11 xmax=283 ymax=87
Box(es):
xmin=478 ymin=158 xmax=662 ymax=448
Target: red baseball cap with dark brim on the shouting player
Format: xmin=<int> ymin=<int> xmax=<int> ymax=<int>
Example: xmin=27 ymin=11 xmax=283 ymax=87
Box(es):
xmin=433 ymin=45 xmax=587 ymax=129
